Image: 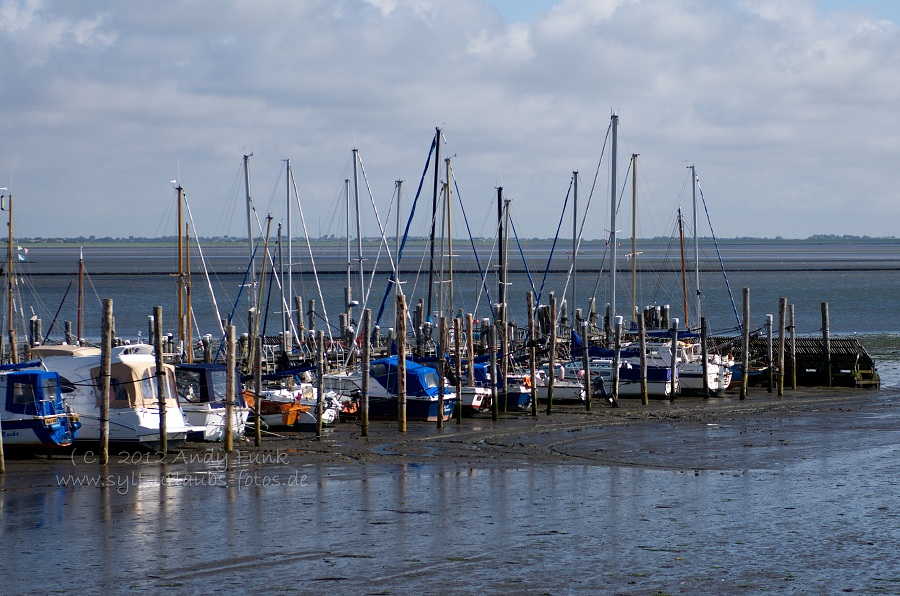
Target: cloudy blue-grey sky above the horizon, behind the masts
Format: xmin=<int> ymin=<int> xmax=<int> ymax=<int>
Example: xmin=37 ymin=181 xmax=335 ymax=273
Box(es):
xmin=0 ymin=0 xmax=900 ymax=238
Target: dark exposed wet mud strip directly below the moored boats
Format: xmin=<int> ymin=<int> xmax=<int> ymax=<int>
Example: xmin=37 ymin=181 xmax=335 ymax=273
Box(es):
xmin=2 ymin=388 xmax=900 ymax=480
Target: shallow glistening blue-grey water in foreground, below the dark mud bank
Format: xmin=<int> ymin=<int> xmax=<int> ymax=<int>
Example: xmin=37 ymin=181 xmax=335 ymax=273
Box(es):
xmin=0 ymin=393 xmax=900 ymax=594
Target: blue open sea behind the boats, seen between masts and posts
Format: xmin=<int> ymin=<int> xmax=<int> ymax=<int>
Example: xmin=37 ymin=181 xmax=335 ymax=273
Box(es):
xmin=17 ymin=241 xmax=900 ymax=386
